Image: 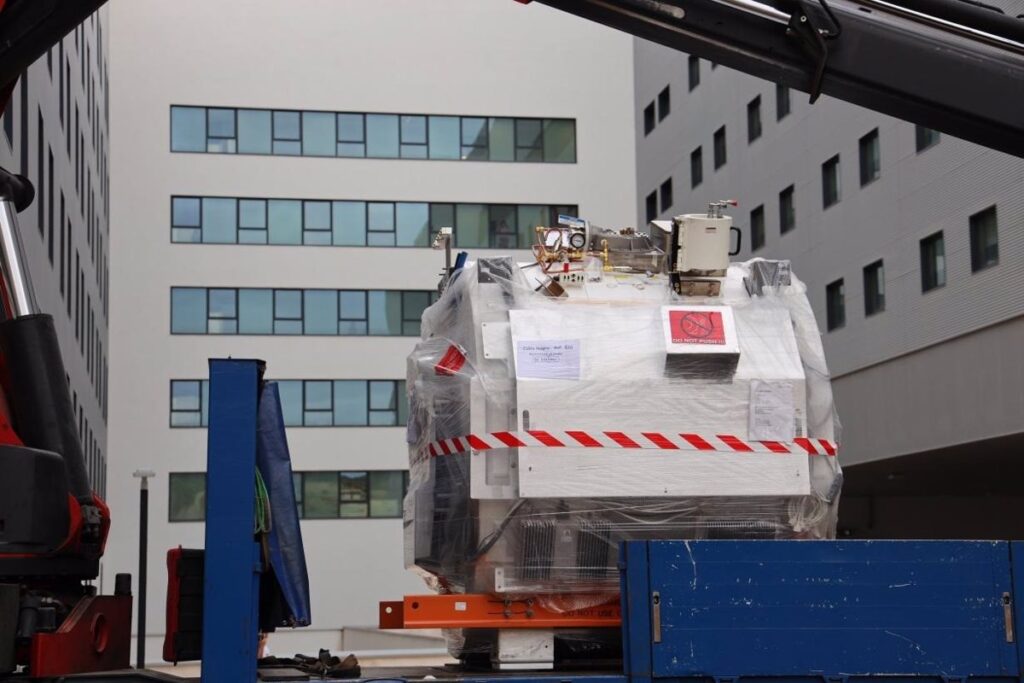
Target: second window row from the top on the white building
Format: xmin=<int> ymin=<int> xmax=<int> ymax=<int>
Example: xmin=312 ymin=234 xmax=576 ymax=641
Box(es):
xmin=171 ymin=197 xmax=579 ymax=249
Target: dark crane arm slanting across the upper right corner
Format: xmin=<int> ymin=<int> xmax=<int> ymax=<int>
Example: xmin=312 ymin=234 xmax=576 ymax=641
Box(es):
xmin=538 ymin=0 xmax=1024 ymax=157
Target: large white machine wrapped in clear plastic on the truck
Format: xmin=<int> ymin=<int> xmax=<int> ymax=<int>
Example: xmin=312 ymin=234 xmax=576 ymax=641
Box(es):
xmin=404 ymin=203 xmax=842 ymax=668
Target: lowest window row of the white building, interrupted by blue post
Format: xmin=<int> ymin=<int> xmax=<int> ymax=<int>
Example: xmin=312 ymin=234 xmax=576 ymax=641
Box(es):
xmin=168 ymin=471 xmax=409 ymax=522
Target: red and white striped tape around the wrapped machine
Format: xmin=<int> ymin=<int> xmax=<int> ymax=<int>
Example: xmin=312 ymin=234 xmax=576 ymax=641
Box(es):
xmin=420 ymin=429 xmax=837 ymax=458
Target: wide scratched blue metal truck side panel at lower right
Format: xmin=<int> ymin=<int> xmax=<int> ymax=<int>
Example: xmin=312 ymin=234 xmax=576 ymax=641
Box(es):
xmin=627 ymin=541 xmax=1020 ymax=680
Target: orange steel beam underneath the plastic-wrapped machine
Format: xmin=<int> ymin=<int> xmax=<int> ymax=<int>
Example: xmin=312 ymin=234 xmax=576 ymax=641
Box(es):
xmin=380 ymin=594 xmax=622 ymax=629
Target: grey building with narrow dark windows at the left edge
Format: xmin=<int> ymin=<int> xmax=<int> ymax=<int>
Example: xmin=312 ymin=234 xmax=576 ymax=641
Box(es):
xmin=0 ymin=9 xmax=113 ymax=509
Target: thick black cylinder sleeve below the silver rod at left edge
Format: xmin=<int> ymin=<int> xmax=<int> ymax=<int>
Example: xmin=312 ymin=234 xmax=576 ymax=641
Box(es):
xmin=0 ymin=313 xmax=92 ymax=504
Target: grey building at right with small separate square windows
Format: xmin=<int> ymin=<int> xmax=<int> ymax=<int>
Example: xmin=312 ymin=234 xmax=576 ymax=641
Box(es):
xmin=635 ymin=40 xmax=1024 ymax=538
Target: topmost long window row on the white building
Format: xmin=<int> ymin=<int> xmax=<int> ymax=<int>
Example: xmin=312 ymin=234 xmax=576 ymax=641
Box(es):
xmin=171 ymin=107 xmax=581 ymax=164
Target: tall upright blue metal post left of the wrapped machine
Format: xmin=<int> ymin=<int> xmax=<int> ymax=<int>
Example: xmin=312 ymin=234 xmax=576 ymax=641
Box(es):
xmin=203 ymin=359 xmax=262 ymax=683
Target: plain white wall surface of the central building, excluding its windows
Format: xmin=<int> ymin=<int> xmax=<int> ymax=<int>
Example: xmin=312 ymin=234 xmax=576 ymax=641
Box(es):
xmin=106 ymin=0 xmax=636 ymax=659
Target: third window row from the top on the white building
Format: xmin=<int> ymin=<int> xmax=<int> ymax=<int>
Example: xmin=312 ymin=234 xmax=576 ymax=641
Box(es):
xmin=171 ymin=287 xmax=437 ymax=336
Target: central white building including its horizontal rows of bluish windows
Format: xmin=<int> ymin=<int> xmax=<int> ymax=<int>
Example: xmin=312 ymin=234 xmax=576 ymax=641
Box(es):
xmin=106 ymin=0 xmax=636 ymax=659
